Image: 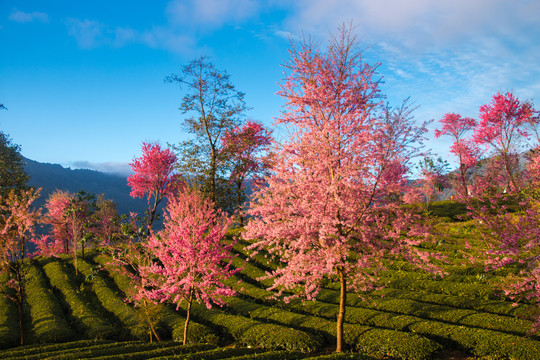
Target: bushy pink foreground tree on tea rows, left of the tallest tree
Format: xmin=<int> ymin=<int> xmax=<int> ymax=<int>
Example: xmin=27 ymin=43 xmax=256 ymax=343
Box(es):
xmin=138 ymin=185 xmax=239 ymax=345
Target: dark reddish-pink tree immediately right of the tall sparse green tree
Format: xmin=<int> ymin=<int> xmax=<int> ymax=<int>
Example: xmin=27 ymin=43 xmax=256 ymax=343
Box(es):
xmin=221 ymin=120 xmax=273 ymax=226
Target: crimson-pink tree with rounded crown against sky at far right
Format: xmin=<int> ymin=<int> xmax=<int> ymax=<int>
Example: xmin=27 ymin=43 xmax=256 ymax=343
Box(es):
xmin=473 ymin=92 xmax=537 ymax=192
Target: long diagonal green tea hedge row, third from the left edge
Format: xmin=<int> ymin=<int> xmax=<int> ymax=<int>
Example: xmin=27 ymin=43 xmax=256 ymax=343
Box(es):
xmin=40 ymin=258 xmax=119 ymax=339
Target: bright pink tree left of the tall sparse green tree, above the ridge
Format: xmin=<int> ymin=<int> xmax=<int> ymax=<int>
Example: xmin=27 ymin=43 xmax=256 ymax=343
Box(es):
xmin=127 ymin=143 xmax=180 ymax=236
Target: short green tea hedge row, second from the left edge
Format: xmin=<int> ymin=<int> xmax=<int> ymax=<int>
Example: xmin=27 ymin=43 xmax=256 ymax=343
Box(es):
xmin=26 ymin=262 xmax=73 ymax=343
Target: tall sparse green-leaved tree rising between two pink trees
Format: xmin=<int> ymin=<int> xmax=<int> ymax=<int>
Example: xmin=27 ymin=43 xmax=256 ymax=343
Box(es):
xmin=165 ymin=56 xmax=248 ymax=208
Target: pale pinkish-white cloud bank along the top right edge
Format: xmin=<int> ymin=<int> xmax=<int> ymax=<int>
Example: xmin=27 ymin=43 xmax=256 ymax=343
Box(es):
xmin=285 ymin=0 xmax=540 ymax=51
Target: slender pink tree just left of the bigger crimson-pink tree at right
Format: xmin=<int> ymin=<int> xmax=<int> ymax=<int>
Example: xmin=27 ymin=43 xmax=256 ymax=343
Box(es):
xmin=435 ymin=113 xmax=480 ymax=199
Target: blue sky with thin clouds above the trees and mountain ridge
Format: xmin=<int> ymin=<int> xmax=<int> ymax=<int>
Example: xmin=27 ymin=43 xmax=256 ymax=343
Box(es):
xmin=0 ymin=0 xmax=540 ymax=176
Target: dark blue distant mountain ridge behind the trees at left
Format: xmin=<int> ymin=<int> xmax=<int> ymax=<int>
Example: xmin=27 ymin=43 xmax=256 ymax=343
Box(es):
xmin=24 ymin=158 xmax=146 ymax=215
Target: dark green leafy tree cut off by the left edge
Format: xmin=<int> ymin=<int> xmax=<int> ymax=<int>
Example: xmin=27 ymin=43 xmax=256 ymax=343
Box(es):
xmin=0 ymin=131 xmax=30 ymax=197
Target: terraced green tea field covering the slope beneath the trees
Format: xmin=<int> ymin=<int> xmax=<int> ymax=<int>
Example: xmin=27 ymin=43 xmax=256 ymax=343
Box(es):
xmin=0 ymin=201 xmax=540 ymax=359
